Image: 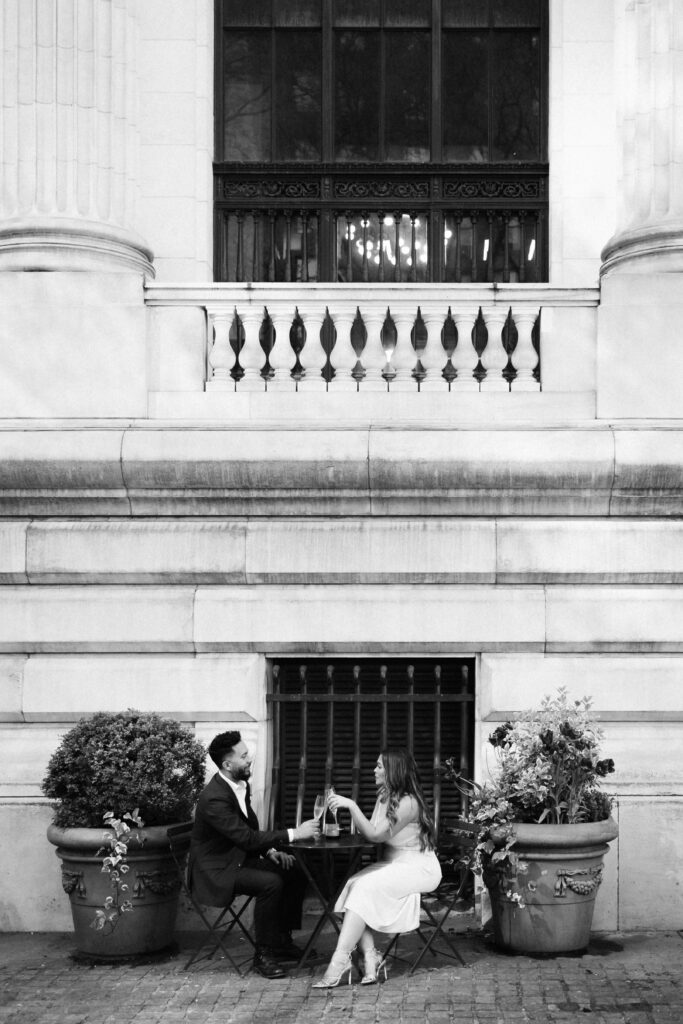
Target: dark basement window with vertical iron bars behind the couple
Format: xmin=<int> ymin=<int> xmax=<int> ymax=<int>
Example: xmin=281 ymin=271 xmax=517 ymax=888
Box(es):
xmin=266 ymin=658 xmax=474 ymax=833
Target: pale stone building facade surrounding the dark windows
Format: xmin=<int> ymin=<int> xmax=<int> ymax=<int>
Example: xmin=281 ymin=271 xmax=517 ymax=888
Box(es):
xmin=0 ymin=0 xmax=683 ymax=930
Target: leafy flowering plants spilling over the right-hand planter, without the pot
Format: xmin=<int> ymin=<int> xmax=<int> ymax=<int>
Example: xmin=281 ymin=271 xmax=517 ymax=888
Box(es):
xmin=444 ymin=687 xmax=614 ymax=898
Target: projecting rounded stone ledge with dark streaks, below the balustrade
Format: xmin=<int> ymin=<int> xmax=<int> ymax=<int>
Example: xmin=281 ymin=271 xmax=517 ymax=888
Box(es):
xmin=0 ymin=424 xmax=683 ymax=517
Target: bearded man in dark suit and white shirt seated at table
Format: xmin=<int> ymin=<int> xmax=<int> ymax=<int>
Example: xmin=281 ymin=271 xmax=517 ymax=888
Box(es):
xmin=188 ymin=732 xmax=318 ymax=978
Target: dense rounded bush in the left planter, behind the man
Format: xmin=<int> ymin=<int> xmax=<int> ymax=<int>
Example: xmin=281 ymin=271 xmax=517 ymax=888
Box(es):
xmin=42 ymin=710 xmax=206 ymax=828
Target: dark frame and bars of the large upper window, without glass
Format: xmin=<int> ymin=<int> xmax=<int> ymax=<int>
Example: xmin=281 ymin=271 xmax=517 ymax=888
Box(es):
xmin=214 ymin=0 xmax=548 ymax=283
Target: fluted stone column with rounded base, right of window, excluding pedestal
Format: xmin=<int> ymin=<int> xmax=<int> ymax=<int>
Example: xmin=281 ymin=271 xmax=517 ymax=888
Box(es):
xmin=602 ymin=0 xmax=683 ymax=274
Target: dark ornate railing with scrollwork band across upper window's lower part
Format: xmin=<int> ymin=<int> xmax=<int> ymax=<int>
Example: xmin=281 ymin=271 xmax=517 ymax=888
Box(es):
xmin=215 ymin=165 xmax=548 ymax=284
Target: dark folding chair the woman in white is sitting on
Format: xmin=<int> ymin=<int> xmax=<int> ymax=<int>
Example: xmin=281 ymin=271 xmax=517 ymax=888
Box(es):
xmin=384 ymin=821 xmax=476 ymax=974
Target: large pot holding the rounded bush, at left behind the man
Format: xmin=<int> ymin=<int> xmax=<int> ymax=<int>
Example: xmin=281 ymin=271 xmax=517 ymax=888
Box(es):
xmin=47 ymin=825 xmax=189 ymax=961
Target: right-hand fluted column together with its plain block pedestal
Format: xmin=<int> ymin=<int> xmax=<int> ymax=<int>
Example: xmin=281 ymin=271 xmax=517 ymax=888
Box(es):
xmin=597 ymin=0 xmax=683 ymax=422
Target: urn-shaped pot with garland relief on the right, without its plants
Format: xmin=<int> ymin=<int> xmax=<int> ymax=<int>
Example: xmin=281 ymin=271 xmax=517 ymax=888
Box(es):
xmin=484 ymin=818 xmax=618 ymax=954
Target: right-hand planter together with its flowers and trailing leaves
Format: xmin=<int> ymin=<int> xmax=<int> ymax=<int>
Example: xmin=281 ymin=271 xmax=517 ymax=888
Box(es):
xmin=445 ymin=687 xmax=617 ymax=952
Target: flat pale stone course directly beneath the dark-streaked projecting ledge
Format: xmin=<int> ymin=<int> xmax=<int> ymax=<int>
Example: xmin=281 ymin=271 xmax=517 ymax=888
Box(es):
xmin=0 ymin=516 xmax=683 ymax=585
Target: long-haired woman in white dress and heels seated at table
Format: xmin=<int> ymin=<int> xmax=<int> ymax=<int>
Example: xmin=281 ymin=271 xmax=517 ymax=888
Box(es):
xmin=313 ymin=750 xmax=441 ymax=988
